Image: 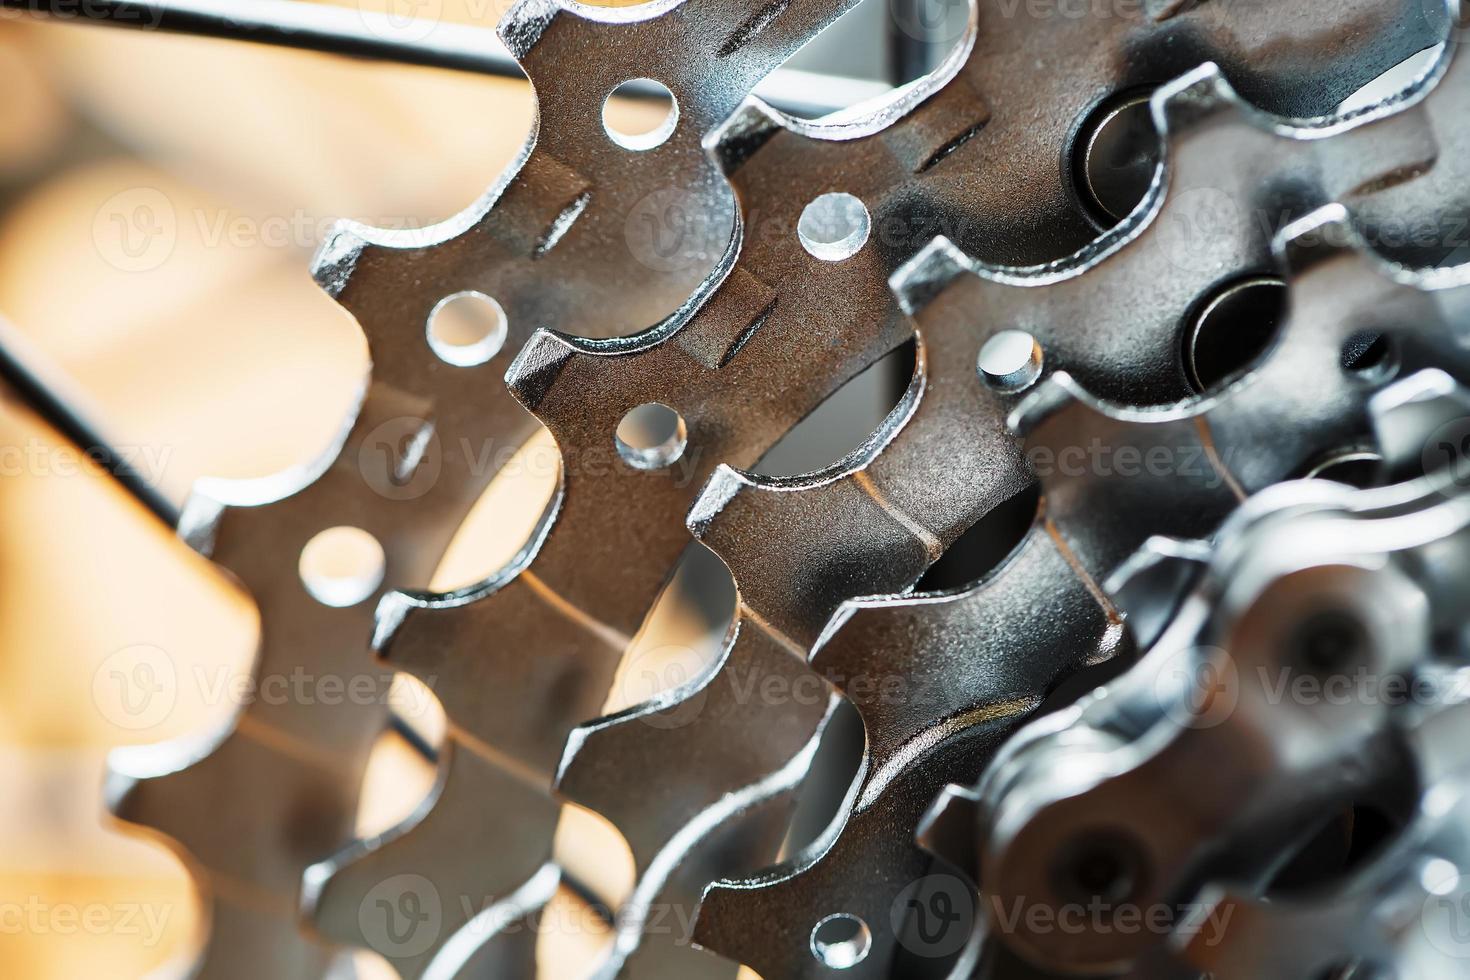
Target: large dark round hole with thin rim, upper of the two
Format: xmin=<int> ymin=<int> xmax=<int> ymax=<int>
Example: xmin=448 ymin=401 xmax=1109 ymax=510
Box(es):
xmin=1075 ymin=93 xmax=1163 ymax=228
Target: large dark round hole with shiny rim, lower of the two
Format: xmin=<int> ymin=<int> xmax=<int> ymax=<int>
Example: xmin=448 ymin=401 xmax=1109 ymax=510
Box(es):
xmin=1185 ymin=276 xmax=1286 ymax=391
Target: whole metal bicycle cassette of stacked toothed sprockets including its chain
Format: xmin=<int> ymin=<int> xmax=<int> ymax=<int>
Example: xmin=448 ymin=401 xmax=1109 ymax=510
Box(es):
xmin=0 ymin=0 xmax=1470 ymax=980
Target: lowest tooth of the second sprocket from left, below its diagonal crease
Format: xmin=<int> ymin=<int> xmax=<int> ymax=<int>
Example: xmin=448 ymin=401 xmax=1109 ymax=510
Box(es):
xmin=301 ymin=741 xmax=559 ymax=980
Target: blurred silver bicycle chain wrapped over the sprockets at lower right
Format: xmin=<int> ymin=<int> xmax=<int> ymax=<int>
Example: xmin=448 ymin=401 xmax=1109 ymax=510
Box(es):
xmin=970 ymin=365 xmax=1470 ymax=980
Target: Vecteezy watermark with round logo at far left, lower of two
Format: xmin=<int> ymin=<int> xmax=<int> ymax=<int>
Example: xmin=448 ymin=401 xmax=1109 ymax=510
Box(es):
xmin=93 ymin=644 xmax=437 ymax=730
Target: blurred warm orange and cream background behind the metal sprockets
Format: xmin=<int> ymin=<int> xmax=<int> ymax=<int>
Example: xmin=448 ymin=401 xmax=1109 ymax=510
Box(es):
xmin=0 ymin=0 xmax=682 ymax=980
